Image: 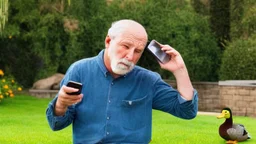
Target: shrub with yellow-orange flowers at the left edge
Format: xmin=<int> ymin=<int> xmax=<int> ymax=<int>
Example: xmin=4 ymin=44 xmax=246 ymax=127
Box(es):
xmin=0 ymin=69 xmax=22 ymax=102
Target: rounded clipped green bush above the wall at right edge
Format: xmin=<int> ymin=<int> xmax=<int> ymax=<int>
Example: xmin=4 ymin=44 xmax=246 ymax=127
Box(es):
xmin=220 ymin=35 xmax=256 ymax=80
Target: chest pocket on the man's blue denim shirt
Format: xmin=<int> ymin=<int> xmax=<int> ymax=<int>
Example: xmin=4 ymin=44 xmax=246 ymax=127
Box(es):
xmin=121 ymin=95 xmax=148 ymax=130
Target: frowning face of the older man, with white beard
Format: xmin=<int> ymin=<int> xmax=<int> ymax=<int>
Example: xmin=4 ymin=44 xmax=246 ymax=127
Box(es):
xmin=108 ymin=34 xmax=146 ymax=75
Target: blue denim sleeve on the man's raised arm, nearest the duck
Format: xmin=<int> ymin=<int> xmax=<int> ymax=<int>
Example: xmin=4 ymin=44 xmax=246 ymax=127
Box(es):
xmin=153 ymin=79 xmax=198 ymax=119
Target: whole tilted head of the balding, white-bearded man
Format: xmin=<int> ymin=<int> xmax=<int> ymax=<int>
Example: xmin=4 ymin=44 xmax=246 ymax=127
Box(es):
xmin=104 ymin=20 xmax=148 ymax=75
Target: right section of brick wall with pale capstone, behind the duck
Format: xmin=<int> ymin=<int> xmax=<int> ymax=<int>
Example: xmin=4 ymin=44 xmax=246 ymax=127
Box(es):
xmin=219 ymin=81 xmax=256 ymax=117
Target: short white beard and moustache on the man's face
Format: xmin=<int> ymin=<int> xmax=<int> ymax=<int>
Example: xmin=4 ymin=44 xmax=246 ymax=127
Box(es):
xmin=108 ymin=51 xmax=135 ymax=75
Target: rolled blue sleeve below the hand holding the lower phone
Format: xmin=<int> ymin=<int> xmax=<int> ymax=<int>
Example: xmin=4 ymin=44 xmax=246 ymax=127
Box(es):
xmin=46 ymin=96 xmax=74 ymax=131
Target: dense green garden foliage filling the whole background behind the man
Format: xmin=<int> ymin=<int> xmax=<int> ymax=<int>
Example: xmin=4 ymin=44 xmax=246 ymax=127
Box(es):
xmin=0 ymin=0 xmax=256 ymax=88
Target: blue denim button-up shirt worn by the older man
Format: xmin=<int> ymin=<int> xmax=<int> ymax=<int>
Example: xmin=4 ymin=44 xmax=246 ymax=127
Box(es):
xmin=46 ymin=50 xmax=198 ymax=144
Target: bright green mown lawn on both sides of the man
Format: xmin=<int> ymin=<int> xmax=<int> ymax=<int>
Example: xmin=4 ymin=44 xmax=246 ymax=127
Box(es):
xmin=0 ymin=95 xmax=256 ymax=144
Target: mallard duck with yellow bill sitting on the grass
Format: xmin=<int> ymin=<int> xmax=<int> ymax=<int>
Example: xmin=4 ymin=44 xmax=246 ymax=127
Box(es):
xmin=217 ymin=108 xmax=251 ymax=144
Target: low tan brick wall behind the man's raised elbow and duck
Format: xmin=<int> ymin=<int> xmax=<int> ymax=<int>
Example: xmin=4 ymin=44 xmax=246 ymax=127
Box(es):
xmin=166 ymin=80 xmax=256 ymax=117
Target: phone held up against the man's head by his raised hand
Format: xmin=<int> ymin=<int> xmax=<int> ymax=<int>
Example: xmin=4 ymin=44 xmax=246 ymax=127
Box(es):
xmin=147 ymin=40 xmax=171 ymax=63
